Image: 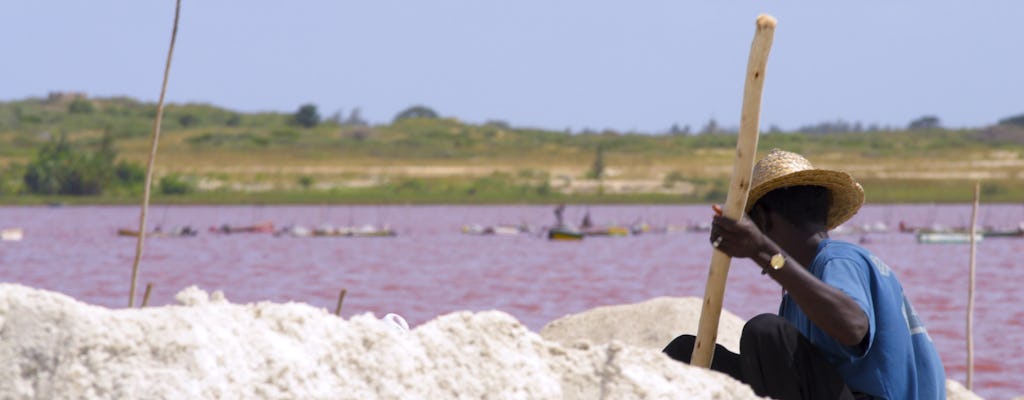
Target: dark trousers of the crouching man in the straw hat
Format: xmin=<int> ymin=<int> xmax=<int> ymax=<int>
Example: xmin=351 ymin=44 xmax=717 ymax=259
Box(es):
xmin=663 ymin=314 xmax=854 ymax=400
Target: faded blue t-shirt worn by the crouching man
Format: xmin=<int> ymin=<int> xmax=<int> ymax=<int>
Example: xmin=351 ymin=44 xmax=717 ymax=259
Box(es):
xmin=778 ymin=239 xmax=946 ymax=399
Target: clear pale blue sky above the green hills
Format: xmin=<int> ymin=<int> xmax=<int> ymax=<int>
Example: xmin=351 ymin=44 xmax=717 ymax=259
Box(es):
xmin=0 ymin=0 xmax=1024 ymax=132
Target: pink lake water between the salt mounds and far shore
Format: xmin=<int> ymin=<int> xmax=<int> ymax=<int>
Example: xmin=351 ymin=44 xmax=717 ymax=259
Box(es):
xmin=0 ymin=205 xmax=1024 ymax=399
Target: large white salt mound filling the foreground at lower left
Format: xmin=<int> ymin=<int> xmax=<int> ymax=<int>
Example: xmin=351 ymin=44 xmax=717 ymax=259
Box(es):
xmin=0 ymin=284 xmax=757 ymax=399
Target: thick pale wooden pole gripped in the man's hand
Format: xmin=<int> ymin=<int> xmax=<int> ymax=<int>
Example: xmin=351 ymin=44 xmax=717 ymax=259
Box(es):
xmin=690 ymin=14 xmax=775 ymax=368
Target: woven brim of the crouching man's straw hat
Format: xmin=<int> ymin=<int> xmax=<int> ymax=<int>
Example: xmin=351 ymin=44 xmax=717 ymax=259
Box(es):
xmin=746 ymin=170 xmax=864 ymax=230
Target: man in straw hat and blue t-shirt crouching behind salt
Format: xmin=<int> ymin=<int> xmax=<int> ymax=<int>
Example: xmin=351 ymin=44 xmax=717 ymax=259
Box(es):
xmin=665 ymin=149 xmax=945 ymax=399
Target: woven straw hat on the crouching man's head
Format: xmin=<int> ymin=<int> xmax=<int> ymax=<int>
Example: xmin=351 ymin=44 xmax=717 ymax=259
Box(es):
xmin=746 ymin=148 xmax=864 ymax=229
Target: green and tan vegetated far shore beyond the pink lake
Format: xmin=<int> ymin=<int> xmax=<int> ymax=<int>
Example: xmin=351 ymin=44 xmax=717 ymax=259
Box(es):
xmin=0 ymin=95 xmax=1024 ymax=204
